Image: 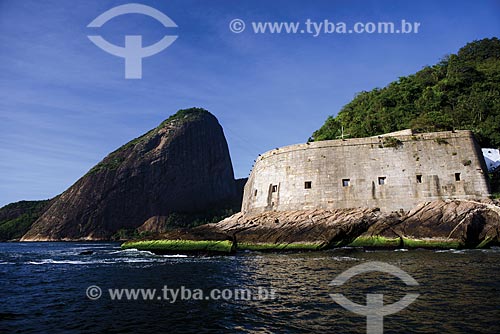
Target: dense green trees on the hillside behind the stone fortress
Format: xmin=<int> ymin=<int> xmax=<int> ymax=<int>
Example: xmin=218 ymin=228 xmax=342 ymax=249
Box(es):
xmin=310 ymin=38 xmax=500 ymax=147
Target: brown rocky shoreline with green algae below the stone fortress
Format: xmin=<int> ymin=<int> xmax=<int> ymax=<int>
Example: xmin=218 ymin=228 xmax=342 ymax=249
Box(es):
xmin=122 ymin=200 xmax=500 ymax=254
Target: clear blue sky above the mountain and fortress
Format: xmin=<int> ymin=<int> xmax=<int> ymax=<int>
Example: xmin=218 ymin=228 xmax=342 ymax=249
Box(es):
xmin=0 ymin=0 xmax=500 ymax=206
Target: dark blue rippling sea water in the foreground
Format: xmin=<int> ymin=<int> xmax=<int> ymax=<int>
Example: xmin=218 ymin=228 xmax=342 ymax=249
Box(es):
xmin=0 ymin=242 xmax=500 ymax=333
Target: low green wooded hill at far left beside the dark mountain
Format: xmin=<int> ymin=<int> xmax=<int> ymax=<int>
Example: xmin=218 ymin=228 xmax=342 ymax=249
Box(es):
xmin=0 ymin=200 xmax=51 ymax=241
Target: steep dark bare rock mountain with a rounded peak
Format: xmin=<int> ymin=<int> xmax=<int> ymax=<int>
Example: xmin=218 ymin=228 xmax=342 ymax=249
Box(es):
xmin=22 ymin=108 xmax=237 ymax=241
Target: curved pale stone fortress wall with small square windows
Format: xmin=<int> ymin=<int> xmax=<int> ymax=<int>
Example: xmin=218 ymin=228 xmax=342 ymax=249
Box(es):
xmin=242 ymin=130 xmax=490 ymax=214
